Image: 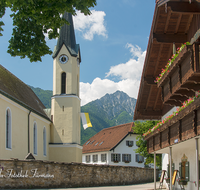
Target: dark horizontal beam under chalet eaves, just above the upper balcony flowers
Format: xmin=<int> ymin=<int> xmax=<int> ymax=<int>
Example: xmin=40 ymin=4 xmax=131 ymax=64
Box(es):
xmin=153 ymin=33 xmax=187 ymax=43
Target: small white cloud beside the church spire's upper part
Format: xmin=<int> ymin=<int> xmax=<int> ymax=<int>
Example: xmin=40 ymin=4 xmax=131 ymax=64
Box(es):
xmin=73 ymin=10 xmax=108 ymax=40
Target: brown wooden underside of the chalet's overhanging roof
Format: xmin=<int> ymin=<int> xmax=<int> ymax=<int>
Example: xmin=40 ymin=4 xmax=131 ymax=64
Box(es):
xmin=133 ymin=0 xmax=200 ymax=120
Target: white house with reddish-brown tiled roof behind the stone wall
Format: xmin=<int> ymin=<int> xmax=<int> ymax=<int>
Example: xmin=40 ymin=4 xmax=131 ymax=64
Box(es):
xmin=82 ymin=122 xmax=144 ymax=167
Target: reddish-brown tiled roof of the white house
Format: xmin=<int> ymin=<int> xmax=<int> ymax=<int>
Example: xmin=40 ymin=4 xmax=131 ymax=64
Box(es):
xmin=83 ymin=122 xmax=134 ymax=154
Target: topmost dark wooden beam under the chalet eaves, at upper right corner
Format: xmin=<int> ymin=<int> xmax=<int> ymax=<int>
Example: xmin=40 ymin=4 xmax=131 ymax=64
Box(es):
xmin=167 ymin=1 xmax=200 ymax=14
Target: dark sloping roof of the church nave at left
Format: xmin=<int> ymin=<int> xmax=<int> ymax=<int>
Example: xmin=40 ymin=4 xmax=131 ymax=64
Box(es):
xmin=0 ymin=65 xmax=49 ymax=120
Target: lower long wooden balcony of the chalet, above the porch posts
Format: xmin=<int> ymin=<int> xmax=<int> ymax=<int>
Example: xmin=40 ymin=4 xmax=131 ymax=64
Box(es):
xmin=145 ymin=95 xmax=200 ymax=153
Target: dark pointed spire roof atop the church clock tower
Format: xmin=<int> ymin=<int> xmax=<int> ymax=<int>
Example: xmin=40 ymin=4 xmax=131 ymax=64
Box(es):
xmin=52 ymin=12 xmax=80 ymax=58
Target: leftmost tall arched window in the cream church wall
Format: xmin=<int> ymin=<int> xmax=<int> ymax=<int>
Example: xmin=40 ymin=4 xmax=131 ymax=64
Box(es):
xmin=6 ymin=109 xmax=12 ymax=149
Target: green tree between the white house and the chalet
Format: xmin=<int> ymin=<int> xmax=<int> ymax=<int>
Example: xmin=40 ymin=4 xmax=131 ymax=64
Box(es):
xmin=134 ymin=121 xmax=162 ymax=168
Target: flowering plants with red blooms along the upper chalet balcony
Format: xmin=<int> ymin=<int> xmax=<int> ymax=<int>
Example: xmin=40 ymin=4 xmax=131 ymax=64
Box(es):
xmin=154 ymin=42 xmax=190 ymax=83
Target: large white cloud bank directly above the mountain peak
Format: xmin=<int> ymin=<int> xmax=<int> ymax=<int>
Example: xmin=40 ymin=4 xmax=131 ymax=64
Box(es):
xmin=80 ymin=44 xmax=146 ymax=105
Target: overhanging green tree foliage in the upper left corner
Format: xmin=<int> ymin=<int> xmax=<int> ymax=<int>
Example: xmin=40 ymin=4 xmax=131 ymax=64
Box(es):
xmin=0 ymin=0 xmax=96 ymax=62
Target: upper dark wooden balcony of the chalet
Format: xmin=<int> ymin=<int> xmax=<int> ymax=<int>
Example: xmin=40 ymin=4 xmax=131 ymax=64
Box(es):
xmin=157 ymin=42 xmax=200 ymax=106
